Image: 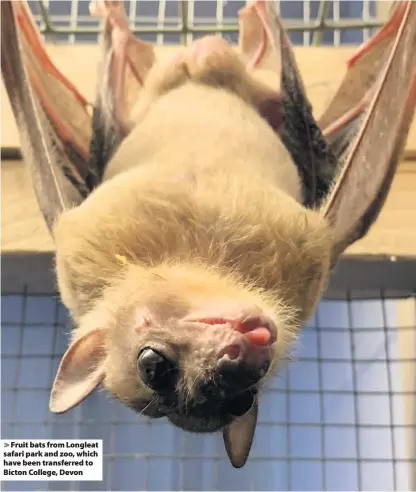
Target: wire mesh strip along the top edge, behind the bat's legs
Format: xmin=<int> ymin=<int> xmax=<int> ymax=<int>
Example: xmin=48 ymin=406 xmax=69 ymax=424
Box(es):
xmin=29 ymin=0 xmax=383 ymax=46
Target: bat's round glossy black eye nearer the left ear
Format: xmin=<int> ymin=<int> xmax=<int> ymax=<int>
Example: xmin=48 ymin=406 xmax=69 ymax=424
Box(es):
xmin=137 ymin=347 xmax=177 ymax=393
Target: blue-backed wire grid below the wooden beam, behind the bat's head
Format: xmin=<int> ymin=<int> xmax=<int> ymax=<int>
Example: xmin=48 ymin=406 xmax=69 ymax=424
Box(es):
xmin=1 ymin=296 xmax=409 ymax=491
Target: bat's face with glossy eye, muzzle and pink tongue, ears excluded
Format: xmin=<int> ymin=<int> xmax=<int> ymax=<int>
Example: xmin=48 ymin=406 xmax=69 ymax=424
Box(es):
xmin=104 ymin=272 xmax=280 ymax=432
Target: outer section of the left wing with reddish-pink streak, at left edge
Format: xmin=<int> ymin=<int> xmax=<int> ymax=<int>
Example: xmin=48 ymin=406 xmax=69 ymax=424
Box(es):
xmin=1 ymin=2 xmax=91 ymax=230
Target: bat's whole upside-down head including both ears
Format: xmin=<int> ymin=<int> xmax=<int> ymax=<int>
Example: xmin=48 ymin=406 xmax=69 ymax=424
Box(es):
xmin=50 ymin=265 xmax=302 ymax=466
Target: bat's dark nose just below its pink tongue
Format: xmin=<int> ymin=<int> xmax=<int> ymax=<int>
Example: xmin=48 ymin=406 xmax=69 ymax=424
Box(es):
xmin=216 ymin=343 xmax=271 ymax=392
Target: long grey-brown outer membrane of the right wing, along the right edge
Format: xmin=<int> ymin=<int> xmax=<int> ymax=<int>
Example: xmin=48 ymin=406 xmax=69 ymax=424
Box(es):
xmin=321 ymin=1 xmax=416 ymax=263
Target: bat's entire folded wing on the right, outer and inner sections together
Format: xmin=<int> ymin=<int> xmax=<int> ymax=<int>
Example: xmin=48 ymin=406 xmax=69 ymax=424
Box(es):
xmin=240 ymin=1 xmax=416 ymax=262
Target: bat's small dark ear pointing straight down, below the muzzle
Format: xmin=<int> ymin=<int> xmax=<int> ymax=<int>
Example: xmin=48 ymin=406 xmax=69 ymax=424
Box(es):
xmin=223 ymin=397 xmax=259 ymax=468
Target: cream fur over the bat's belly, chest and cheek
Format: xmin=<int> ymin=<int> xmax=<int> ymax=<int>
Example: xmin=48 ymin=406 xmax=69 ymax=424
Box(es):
xmin=55 ymin=56 xmax=331 ymax=412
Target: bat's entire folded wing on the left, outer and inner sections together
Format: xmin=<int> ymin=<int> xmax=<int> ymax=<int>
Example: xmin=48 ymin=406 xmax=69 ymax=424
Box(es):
xmin=1 ymin=1 xmax=154 ymax=231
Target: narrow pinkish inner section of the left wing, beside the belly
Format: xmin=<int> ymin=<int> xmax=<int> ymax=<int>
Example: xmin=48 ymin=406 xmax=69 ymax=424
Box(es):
xmin=90 ymin=0 xmax=155 ymax=177
